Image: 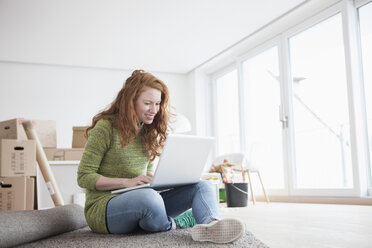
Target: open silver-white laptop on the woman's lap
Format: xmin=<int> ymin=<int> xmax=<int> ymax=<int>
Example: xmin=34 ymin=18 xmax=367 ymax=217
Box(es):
xmin=111 ymin=134 xmax=214 ymax=194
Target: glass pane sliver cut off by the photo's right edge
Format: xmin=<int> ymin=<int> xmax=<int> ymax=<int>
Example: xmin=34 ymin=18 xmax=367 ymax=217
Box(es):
xmin=359 ymin=3 xmax=372 ymax=184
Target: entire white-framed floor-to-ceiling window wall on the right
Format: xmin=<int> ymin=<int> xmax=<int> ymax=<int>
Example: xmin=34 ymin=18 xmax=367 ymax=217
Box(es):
xmin=212 ymin=0 xmax=372 ymax=196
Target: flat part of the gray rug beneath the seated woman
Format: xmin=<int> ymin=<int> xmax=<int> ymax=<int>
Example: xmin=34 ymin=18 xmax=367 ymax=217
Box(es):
xmin=19 ymin=227 xmax=268 ymax=248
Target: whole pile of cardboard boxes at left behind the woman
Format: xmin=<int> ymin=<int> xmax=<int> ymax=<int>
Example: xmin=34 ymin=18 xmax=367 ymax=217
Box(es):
xmin=0 ymin=119 xmax=86 ymax=212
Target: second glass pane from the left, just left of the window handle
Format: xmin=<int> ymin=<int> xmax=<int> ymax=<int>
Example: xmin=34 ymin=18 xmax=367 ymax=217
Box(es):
xmin=243 ymin=47 xmax=284 ymax=189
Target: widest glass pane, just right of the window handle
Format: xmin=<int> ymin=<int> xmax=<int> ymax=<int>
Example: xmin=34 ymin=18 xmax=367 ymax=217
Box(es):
xmin=290 ymin=14 xmax=353 ymax=188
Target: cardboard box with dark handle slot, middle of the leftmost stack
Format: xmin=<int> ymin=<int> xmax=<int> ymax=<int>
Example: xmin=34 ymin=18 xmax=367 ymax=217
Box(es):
xmin=0 ymin=139 xmax=36 ymax=177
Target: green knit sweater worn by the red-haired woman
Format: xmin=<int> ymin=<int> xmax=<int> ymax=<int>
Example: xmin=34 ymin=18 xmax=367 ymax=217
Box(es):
xmin=77 ymin=120 xmax=153 ymax=233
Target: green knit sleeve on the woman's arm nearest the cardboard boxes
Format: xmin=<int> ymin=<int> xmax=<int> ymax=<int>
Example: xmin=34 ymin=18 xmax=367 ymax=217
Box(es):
xmin=78 ymin=120 xmax=112 ymax=190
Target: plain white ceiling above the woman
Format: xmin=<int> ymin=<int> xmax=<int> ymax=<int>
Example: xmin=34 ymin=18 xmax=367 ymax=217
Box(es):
xmin=0 ymin=0 xmax=305 ymax=73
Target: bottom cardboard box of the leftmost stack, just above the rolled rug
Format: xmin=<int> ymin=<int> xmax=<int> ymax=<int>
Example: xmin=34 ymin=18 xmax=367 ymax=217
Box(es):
xmin=0 ymin=177 xmax=35 ymax=211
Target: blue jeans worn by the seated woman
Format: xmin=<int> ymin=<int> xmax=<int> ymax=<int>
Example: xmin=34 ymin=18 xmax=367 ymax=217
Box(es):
xmin=106 ymin=181 xmax=220 ymax=233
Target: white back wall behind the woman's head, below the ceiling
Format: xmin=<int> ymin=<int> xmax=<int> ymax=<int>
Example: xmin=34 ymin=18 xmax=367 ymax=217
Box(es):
xmin=0 ymin=62 xmax=190 ymax=148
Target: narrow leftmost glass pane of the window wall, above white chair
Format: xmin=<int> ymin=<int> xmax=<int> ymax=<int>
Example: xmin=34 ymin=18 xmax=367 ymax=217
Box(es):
xmin=216 ymin=70 xmax=240 ymax=154
